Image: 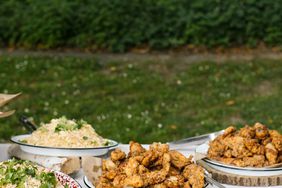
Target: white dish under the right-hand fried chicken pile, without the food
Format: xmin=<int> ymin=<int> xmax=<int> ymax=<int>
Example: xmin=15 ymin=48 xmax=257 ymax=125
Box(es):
xmin=196 ymin=142 xmax=282 ymax=176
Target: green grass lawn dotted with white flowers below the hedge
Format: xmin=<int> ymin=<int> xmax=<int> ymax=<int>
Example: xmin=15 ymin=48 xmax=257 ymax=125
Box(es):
xmin=0 ymin=56 xmax=282 ymax=143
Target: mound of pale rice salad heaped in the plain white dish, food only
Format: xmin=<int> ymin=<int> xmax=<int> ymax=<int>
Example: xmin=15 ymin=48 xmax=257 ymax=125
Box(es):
xmin=22 ymin=117 xmax=109 ymax=148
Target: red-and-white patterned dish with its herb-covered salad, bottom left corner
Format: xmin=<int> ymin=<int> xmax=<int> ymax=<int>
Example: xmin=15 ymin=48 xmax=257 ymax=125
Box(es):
xmin=0 ymin=159 xmax=81 ymax=188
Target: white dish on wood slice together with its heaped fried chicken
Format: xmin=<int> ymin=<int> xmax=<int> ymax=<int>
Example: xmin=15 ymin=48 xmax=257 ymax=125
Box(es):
xmin=196 ymin=123 xmax=282 ymax=176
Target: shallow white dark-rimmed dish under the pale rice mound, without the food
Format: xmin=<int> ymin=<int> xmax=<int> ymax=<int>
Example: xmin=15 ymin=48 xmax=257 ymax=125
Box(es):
xmin=11 ymin=134 xmax=118 ymax=157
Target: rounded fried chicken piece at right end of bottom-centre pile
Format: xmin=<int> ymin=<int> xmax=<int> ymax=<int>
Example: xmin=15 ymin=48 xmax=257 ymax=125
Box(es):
xmin=182 ymin=164 xmax=205 ymax=188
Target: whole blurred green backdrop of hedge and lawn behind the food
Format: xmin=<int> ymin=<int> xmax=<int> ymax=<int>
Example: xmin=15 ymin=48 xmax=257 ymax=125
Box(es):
xmin=0 ymin=0 xmax=282 ymax=143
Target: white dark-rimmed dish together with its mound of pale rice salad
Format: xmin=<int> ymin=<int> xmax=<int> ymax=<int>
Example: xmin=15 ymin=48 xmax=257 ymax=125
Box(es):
xmin=11 ymin=117 xmax=118 ymax=156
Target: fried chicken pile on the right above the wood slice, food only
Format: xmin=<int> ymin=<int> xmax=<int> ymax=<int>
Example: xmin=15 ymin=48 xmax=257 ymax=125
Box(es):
xmin=208 ymin=123 xmax=282 ymax=167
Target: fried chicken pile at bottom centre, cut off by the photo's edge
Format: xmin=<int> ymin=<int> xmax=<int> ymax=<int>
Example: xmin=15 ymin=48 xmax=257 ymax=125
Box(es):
xmin=95 ymin=142 xmax=205 ymax=188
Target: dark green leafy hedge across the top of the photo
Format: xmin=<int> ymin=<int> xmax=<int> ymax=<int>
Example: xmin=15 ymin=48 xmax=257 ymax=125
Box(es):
xmin=0 ymin=0 xmax=282 ymax=52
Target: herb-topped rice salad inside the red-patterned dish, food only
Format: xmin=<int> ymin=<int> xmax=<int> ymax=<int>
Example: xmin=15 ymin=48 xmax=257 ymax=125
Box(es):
xmin=0 ymin=159 xmax=63 ymax=188
